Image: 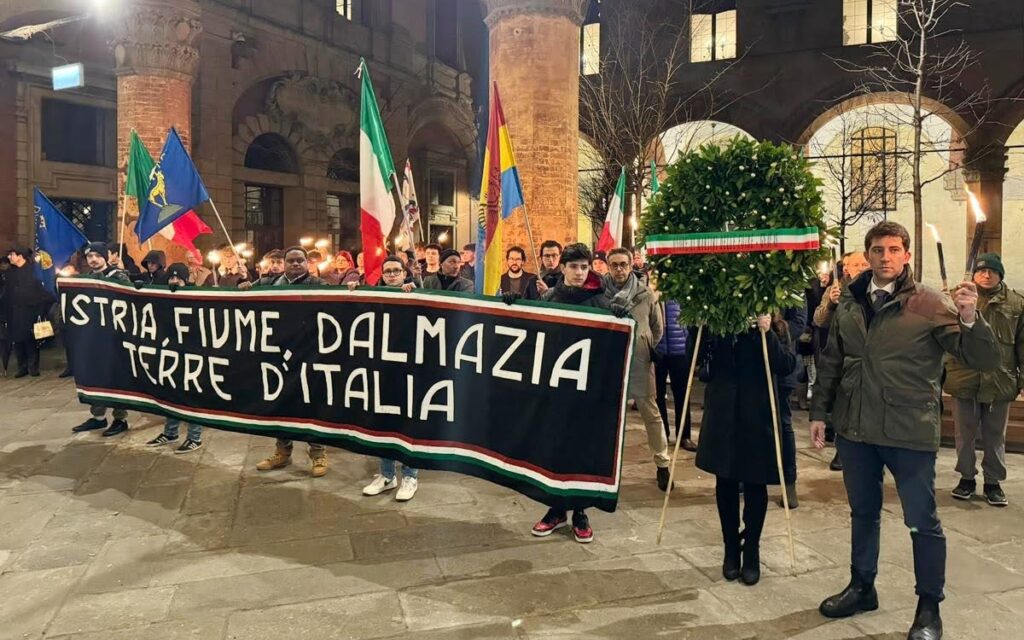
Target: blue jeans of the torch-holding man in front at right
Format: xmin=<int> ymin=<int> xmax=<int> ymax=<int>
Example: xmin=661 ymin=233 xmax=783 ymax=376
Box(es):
xmin=836 ymin=435 xmax=946 ymax=601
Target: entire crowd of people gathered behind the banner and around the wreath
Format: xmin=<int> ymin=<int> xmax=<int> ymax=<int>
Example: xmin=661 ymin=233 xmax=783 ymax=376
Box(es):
xmin=0 ymin=222 xmax=1024 ymax=640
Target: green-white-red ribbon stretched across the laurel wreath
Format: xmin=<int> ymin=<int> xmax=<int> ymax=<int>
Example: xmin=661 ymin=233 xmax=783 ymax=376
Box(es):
xmin=646 ymin=226 xmax=821 ymax=256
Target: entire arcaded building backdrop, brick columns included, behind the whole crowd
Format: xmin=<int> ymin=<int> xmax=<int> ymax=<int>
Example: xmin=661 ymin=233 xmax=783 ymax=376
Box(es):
xmin=0 ymin=0 xmax=1024 ymax=281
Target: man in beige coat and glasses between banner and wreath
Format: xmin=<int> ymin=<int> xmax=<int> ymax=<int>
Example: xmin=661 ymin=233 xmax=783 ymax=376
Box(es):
xmin=602 ymin=247 xmax=670 ymax=492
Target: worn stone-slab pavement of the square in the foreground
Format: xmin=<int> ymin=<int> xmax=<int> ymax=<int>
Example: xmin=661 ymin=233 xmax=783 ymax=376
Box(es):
xmin=0 ymin=372 xmax=1024 ymax=640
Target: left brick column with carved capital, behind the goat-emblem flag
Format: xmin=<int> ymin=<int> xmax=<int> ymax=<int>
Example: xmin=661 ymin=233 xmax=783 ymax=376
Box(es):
xmin=111 ymin=0 xmax=201 ymax=263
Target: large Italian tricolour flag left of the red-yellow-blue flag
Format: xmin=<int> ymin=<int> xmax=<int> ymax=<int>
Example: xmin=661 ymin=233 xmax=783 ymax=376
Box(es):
xmin=358 ymin=59 xmax=395 ymax=285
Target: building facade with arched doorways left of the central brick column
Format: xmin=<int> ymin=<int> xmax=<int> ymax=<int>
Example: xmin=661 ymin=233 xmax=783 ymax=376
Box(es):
xmin=0 ymin=0 xmax=485 ymax=262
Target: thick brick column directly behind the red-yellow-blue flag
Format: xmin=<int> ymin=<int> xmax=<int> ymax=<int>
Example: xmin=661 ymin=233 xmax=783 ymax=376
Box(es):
xmin=483 ymin=0 xmax=589 ymax=270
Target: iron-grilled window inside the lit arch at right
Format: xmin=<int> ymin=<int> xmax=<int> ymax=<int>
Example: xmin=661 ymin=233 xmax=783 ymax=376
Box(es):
xmin=850 ymin=127 xmax=898 ymax=211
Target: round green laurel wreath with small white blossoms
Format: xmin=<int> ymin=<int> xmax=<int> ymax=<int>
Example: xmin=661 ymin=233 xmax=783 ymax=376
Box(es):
xmin=640 ymin=136 xmax=835 ymax=335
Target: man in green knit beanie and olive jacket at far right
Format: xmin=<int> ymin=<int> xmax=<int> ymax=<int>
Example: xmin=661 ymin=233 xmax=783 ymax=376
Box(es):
xmin=945 ymin=253 xmax=1024 ymax=507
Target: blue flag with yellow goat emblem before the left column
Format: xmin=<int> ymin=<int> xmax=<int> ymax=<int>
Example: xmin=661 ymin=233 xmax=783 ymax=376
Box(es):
xmin=135 ymin=127 xmax=210 ymax=243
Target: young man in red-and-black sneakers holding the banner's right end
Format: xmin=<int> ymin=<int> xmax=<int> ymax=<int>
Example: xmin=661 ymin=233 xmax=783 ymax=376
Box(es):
xmin=528 ymin=243 xmax=606 ymax=544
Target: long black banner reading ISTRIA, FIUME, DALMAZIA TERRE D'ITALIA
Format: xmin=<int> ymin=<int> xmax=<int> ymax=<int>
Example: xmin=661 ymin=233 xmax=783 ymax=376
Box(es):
xmin=59 ymin=278 xmax=633 ymax=511
